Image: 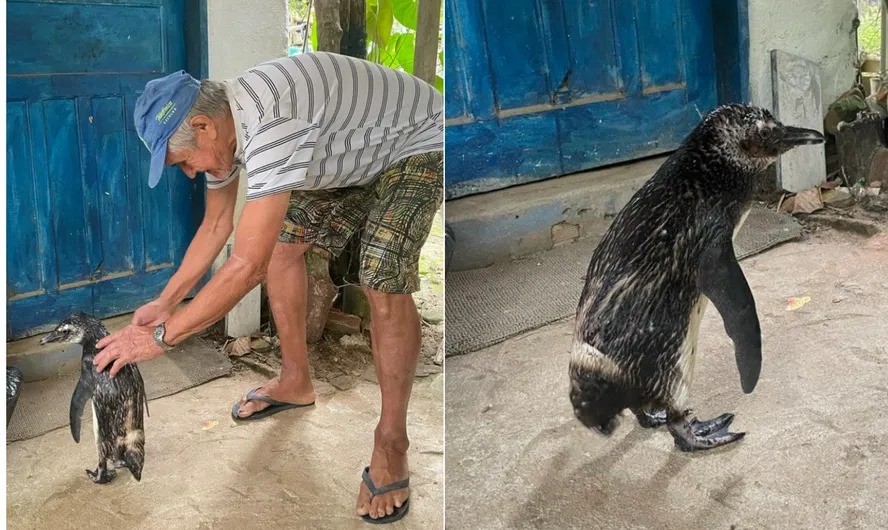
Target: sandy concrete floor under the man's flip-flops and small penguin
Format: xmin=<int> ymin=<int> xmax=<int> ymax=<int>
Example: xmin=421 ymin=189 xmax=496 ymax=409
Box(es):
xmin=6 ymin=372 xmax=444 ymax=530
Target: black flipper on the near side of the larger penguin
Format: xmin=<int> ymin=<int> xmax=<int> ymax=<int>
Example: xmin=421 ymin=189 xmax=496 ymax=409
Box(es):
xmin=697 ymin=232 xmax=762 ymax=394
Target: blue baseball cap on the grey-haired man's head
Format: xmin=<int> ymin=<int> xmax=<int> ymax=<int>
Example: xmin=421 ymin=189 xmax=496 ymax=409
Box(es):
xmin=133 ymin=70 xmax=200 ymax=188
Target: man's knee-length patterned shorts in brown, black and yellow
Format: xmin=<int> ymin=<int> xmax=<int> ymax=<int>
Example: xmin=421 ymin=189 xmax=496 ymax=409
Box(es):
xmin=278 ymin=151 xmax=444 ymax=294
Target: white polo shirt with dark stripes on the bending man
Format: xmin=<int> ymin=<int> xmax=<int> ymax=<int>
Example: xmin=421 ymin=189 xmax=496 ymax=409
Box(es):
xmin=206 ymin=52 xmax=444 ymax=200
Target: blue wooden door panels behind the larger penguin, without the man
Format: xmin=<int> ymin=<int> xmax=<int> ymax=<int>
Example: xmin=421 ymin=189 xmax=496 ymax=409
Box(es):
xmin=445 ymin=0 xmax=717 ymax=198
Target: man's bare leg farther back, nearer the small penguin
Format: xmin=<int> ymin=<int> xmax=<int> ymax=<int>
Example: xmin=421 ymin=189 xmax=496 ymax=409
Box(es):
xmin=238 ymin=242 xmax=315 ymax=418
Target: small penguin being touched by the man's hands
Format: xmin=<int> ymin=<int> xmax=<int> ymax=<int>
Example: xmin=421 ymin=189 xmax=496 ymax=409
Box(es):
xmin=40 ymin=312 xmax=148 ymax=484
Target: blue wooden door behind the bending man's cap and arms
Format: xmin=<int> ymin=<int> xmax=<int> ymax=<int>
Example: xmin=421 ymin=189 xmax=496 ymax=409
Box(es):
xmin=6 ymin=0 xmax=202 ymax=338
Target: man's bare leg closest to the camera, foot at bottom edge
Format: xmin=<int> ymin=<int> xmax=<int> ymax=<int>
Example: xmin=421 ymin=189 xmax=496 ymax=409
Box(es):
xmin=357 ymin=289 xmax=421 ymax=518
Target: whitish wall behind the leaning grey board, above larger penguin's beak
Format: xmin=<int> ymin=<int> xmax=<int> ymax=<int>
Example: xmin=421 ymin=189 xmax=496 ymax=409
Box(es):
xmin=749 ymin=0 xmax=857 ymax=112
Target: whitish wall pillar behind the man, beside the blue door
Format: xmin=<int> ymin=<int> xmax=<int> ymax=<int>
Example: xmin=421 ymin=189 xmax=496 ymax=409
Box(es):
xmin=207 ymin=0 xmax=287 ymax=336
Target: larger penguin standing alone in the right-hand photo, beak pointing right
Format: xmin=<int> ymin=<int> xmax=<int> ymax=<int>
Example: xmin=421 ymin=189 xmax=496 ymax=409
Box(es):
xmin=569 ymin=104 xmax=824 ymax=452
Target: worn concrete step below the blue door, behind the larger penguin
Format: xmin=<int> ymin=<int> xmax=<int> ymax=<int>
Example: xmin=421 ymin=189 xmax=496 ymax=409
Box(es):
xmin=445 ymin=156 xmax=666 ymax=271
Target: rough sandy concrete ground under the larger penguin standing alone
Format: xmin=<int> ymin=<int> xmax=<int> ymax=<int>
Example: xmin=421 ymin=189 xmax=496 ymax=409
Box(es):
xmin=446 ymin=231 xmax=888 ymax=530
